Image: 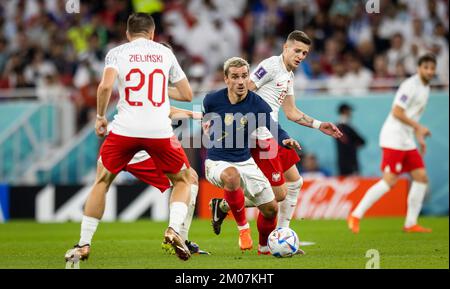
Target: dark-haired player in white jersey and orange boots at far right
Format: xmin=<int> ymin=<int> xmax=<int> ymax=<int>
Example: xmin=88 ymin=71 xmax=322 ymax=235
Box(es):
xmin=347 ymin=54 xmax=436 ymax=233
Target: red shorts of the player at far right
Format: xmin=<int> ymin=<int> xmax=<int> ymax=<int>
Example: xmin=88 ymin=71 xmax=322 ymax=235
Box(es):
xmin=381 ymin=148 xmax=425 ymax=175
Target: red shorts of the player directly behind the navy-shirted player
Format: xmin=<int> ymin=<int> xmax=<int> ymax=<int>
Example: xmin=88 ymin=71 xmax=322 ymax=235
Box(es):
xmin=250 ymin=139 xmax=300 ymax=187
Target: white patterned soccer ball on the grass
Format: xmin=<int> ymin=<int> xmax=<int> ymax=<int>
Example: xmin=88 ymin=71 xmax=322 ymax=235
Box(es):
xmin=267 ymin=228 xmax=300 ymax=258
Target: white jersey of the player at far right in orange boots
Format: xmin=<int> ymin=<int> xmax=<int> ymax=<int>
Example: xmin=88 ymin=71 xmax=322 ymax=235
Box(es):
xmin=380 ymin=74 xmax=430 ymax=151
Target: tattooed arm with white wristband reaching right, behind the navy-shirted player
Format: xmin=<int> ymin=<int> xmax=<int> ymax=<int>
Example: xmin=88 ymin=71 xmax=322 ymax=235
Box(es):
xmin=283 ymin=95 xmax=342 ymax=138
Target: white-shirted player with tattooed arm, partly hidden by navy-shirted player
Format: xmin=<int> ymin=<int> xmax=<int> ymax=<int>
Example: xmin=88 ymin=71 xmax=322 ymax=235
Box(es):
xmin=210 ymin=30 xmax=342 ymax=246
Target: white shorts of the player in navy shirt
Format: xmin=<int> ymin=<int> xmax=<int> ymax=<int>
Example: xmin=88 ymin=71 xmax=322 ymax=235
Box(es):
xmin=205 ymin=158 xmax=275 ymax=207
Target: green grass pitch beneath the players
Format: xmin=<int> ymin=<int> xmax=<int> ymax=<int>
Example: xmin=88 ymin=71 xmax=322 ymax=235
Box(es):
xmin=0 ymin=217 xmax=449 ymax=269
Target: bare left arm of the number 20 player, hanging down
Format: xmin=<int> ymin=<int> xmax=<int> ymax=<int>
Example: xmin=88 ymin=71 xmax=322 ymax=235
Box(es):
xmin=95 ymin=67 xmax=117 ymax=137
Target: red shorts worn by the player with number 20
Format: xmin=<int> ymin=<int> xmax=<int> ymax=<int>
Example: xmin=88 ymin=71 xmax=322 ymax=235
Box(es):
xmin=100 ymin=133 xmax=190 ymax=174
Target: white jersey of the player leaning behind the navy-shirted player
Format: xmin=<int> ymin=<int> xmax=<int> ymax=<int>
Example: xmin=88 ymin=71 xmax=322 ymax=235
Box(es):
xmin=250 ymin=55 xmax=294 ymax=139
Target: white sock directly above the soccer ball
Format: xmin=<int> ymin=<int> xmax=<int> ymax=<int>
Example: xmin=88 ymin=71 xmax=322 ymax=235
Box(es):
xmin=277 ymin=178 xmax=303 ymax=228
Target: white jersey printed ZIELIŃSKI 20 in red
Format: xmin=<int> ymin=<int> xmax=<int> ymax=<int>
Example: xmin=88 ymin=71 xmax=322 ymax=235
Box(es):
xmin=105 ymin=38 xmax=186 ymax=139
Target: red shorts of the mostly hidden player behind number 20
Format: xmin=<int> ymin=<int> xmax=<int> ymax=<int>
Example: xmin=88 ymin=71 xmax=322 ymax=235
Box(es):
xmin=125 ymin=158 xmax=171 ymax=193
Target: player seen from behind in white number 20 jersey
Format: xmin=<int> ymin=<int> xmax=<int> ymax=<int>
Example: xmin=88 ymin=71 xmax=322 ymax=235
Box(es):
xmin=65 ymin=13 xmax=192 ymax=261
